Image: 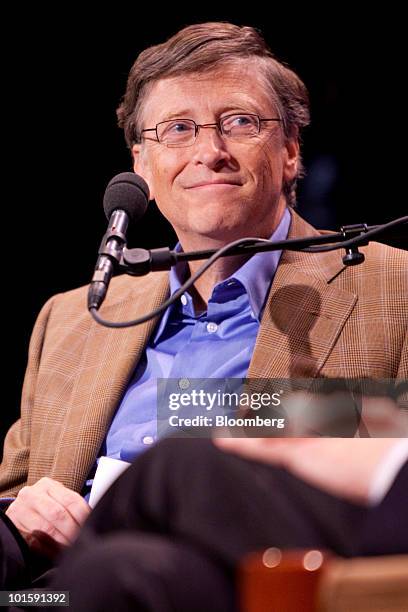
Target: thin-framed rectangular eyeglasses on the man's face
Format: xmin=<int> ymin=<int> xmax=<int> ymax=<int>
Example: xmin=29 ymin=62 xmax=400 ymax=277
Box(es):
xmin=141 ymin=113 xmax=281 ymax=147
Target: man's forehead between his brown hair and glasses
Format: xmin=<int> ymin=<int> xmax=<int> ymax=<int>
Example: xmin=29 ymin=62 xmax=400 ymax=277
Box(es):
xmin=142 ymin=62 xmax=275 ymax=123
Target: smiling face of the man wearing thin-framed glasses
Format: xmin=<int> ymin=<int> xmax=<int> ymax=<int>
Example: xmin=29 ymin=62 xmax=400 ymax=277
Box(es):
xmin=133 ymin=62 xmax=298 ymax=244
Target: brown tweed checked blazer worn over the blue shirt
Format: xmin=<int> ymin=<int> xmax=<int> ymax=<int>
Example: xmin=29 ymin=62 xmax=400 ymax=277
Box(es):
xmin=0 ymin=211 xmax=408 ymax=496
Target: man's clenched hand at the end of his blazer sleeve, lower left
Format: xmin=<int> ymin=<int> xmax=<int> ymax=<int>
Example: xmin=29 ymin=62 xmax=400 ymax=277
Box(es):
xmin=6 ymin=478 xmax=91 ymax=558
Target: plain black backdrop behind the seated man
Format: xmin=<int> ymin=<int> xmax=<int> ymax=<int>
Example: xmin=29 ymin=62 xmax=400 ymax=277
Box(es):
xmin=0 ymin=4 xmax=407 ymax=448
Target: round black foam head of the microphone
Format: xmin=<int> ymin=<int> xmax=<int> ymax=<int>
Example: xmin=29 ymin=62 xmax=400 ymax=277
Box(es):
xmin=103 ymin=172 xmax=149 ymax=222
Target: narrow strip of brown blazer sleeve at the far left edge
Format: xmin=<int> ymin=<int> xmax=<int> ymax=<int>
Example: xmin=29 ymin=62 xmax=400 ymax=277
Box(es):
xmin=0 ymin=296 xmax=57 ymax=497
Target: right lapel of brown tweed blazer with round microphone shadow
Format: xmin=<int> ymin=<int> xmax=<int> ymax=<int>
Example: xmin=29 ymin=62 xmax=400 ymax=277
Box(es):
xmin=248 ymin=211 xmax=357 ymax=379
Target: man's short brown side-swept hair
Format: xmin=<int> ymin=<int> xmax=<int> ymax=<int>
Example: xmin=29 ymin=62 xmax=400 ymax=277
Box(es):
xmin=117 ymin=22 xmax=310 ymax=206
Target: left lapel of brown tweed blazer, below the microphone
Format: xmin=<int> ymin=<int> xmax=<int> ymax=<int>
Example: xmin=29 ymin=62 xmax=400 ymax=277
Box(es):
xmin=51 ymin=273 xmax=169 ymax=490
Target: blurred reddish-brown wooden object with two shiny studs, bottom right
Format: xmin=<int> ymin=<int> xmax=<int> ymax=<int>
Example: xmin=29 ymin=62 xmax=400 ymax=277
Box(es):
xmin=238 ymin=548 xmax=408 ymax=612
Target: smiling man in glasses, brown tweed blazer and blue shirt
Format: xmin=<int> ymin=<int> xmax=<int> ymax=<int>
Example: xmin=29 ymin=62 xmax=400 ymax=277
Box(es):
xmin=0 ymin=23 xmax=408 ymax=588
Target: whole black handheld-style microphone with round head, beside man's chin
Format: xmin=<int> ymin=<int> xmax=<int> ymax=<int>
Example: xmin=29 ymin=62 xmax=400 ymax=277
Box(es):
xmin=88 ymin=172 xmax=149 ymax=310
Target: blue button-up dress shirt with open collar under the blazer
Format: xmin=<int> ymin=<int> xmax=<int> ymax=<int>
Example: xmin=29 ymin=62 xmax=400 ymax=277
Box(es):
xmin=83 ymin=209 xmax=290 ymax=498
